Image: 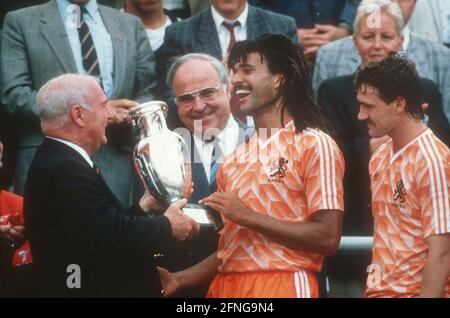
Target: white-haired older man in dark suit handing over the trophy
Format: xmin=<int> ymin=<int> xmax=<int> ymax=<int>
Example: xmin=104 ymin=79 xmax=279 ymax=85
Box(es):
xmin=24 ymin=74 xmax=199 ymax=297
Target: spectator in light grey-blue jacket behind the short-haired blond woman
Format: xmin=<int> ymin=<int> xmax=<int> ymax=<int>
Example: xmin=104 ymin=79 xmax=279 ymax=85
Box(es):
xmin=313 ymin=0 xmax=450 ymax=119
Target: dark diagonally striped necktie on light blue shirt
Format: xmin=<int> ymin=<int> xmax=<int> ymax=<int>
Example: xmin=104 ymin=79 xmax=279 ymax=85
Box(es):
xmin=78 ymin=5 xmax=100 ymax=78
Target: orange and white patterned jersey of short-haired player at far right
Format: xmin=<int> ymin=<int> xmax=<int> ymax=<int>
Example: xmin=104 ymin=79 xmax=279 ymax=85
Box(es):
xmin=365 ymin=129 xmax=450 ymax=297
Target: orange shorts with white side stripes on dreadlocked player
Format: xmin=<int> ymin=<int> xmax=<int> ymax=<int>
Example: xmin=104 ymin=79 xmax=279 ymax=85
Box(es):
xmin=206 ymin=270 xmax=319 ymax=298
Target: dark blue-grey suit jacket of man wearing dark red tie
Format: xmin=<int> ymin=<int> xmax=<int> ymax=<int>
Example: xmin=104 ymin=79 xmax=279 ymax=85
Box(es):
xmin=155 ymin=6 xmax=298 ymax=98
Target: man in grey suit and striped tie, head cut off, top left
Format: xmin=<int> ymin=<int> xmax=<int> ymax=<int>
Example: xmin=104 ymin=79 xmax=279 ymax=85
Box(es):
xmin=1 ymin=0 xmax=155 ymax=203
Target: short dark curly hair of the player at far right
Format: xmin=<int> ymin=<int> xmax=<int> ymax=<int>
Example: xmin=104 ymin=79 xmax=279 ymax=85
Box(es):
xmin=355 ymin=53 xmax=424 ymax=119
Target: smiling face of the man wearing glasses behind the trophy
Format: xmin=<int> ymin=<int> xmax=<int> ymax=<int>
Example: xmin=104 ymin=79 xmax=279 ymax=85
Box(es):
xmin=172 ymin=59 xmax=230 ymax=138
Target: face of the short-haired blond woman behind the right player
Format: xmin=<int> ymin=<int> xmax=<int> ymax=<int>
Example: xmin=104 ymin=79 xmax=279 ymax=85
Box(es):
xmin=353 ymin=11 xmax=403 ymax=66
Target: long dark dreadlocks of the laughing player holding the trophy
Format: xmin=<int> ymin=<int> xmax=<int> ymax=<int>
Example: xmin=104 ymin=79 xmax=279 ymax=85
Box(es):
xmin=228 ymin=34 xmax=331 ymax=133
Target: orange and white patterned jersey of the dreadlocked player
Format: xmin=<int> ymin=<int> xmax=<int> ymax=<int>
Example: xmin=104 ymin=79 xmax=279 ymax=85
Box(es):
xmin=217 ymin=121 xmax=344 ymax=273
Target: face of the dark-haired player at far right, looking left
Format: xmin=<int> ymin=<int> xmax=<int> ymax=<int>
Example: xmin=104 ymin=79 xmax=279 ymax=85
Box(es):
xmin=357 ymin=85 xmax=397 ymax=138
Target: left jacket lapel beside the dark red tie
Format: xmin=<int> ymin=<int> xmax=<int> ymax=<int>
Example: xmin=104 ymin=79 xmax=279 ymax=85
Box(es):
xmin=195 ymin=10 xmax=222 ymax=60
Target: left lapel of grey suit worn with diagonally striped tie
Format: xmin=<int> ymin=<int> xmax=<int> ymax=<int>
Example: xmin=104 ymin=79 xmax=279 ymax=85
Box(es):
xmin=40 ymin=1 xmax=78 ymax=73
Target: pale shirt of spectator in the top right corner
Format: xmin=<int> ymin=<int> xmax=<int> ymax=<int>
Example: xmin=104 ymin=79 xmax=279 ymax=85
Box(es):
xmin=408 ymin=0 xmax=450 ymax=46
